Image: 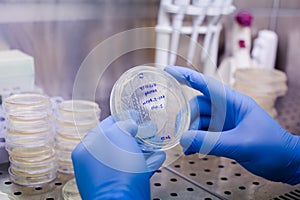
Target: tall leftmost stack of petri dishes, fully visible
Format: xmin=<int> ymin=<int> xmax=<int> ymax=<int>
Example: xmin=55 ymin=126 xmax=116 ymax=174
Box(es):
xmin=4 ymin=93 xmax=57 ymax=186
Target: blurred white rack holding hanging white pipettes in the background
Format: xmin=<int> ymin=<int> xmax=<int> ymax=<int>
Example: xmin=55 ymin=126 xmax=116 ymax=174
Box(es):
xmin=155 ymin=0 xmax=235 ymax=75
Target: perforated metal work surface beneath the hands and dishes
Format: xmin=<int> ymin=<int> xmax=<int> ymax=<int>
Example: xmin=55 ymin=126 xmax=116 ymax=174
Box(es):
xmin=0 ymin=87 xmax=300 ymax=200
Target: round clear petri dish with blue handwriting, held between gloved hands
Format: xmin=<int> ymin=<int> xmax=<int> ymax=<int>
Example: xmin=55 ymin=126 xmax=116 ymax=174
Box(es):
xmin=110 ymin=66 xmax=190 ymax=151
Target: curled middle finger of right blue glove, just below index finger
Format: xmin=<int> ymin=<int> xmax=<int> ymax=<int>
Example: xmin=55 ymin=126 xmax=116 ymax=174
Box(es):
xmin=190 ymin=95 xmax=211 ymax=121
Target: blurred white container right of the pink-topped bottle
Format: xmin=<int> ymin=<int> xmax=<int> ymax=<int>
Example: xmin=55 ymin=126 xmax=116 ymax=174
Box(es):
xmin=251 ymin=30 xmax=278 ymax=69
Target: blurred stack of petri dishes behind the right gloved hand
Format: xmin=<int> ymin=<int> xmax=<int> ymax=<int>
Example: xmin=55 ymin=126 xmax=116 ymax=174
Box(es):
xmin=233 ymin=68 xmax=287 ymax=117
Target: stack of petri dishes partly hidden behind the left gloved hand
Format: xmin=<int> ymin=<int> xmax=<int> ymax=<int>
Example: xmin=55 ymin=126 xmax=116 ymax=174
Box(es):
xmin=55 ymin=100 xmax=100 ymax=174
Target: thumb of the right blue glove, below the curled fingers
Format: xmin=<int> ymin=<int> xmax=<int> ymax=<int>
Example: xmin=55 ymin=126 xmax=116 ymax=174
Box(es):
xmin=180 ymin=131 xmax=237 ymax=159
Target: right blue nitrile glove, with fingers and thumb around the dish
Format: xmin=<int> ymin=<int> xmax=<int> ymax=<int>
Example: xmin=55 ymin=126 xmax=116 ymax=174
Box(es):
xmin=165 ymin=67 xmax=300 ymax=185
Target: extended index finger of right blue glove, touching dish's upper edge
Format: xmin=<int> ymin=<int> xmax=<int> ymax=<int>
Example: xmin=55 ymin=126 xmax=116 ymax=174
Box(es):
xmin=164 ymin=66 xmax=225 ymax=98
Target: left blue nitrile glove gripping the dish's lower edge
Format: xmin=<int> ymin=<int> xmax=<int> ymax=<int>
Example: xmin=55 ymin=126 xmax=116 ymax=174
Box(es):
xmin=72 ymin=116 xmax=165 ymax=200
